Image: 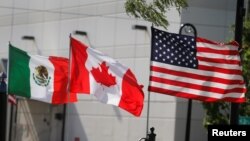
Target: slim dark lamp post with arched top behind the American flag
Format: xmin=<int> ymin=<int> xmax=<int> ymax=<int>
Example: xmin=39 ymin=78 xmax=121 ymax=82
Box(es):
xmin=179 ymin=23 xmax=197 ymax=141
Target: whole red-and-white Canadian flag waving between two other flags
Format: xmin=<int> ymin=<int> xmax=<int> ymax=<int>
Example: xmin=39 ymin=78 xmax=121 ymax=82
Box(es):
xmin=70 ymin=37 xmax=144 ymax=116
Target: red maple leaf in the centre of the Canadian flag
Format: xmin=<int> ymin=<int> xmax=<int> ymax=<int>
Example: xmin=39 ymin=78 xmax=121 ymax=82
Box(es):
xmin=91 ymin=62 xmax=116 ymax=87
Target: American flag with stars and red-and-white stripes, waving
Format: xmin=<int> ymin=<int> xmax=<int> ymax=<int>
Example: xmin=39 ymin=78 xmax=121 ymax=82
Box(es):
xmin=149 ymin=27 xmax=246 ymax=103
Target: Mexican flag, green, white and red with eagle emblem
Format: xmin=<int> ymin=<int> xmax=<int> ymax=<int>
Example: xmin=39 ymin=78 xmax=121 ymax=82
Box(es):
xmin=8 ymin=44 xmax=77 ymax=104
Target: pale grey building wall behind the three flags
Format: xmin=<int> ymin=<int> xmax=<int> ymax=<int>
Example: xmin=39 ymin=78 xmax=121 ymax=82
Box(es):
xmin=0 ymin=0 xmax=236 ymax=141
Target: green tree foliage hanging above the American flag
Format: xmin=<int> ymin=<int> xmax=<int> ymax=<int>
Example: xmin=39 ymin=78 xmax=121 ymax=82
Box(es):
xmin=125 ymin=0 xmax=187 ymax=28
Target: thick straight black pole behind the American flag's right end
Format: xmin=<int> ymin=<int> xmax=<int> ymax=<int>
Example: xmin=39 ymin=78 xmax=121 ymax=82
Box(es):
xmin=230 ymin=0 xmax=245 ymax=125
